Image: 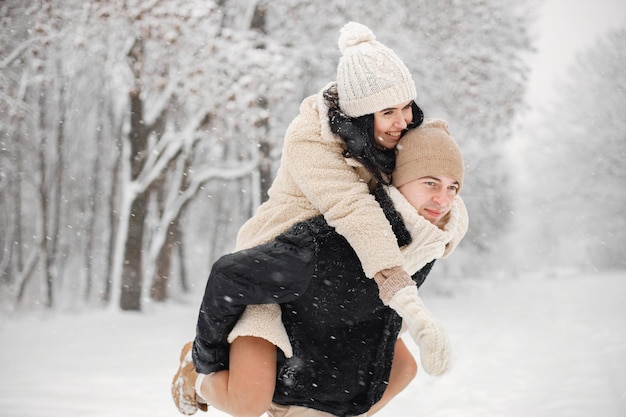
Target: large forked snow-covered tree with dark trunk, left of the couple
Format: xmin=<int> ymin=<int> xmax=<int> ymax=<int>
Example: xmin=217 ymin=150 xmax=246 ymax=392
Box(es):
xmin=91 ymin=1 xmax=300 ymax=309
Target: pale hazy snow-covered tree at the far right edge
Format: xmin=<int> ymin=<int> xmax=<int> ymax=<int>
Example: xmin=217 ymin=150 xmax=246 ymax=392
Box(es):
xmin=518 ymin=28 xmax=626 ymax=269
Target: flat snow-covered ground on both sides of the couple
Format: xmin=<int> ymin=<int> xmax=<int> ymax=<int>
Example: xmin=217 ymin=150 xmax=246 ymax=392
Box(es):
xmin=0 ymin=271 xmax=626 ymax=417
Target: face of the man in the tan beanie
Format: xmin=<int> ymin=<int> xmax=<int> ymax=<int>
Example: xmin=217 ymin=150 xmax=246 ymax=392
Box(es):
xmin=398 ymin=175 xmax=459 ymax=226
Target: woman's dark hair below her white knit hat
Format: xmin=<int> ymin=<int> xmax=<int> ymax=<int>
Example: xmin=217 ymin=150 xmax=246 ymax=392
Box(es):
xmin=324 ymin=86 xmax=424 ymax=185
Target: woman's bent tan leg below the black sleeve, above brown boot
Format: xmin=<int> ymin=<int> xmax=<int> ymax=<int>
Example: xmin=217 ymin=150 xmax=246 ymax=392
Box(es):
xmin=199 ymin=336 xmax=276 ymax=417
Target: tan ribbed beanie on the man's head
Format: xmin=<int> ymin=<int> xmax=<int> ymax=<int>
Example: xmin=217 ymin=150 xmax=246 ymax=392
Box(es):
xmin=392 ymin=119 xmax=465 ymax=189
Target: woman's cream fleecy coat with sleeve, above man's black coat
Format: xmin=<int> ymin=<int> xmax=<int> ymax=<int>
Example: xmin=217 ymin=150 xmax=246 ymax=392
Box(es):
xmin=236 ymin=86 xmax=402 ymax=277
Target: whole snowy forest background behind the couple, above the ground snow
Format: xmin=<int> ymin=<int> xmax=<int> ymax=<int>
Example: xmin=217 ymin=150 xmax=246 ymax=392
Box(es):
xmin=0 ymin=0 xmax=626 ymax=315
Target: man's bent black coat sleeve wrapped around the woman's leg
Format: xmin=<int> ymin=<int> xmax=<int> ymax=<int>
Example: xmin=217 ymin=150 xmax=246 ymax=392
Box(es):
xmin=192 ymin=231 xmax=315 ymax=374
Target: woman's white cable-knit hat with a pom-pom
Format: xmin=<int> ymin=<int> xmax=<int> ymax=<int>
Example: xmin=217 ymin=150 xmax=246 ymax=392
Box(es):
xmin=337 ymin=22 xmax=417 ymax=117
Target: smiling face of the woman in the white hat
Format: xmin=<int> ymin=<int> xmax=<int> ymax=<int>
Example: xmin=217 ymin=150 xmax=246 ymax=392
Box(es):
xmin=374 ymin=101 xmax=413 ymax=149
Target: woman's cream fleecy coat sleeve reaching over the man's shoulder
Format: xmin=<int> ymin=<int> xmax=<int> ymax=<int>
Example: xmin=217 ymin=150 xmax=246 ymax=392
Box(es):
xmin=282 ymin=94 xmax=402 ymax=278
